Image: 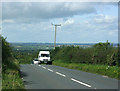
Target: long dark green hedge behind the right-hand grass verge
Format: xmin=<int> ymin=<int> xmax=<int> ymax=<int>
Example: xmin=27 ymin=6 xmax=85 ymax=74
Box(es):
xmin=51 ymin=41 xmax=119 ymax=66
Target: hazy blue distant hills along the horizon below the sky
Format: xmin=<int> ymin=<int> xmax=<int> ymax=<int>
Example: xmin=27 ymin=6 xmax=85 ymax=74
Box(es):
xmin=10 ymin=43 xmax=117 ymax=50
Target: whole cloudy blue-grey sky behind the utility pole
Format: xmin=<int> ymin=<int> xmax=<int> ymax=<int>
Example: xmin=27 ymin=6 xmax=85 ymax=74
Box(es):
xmin=2 ymin=2 xmax=118 ymax=43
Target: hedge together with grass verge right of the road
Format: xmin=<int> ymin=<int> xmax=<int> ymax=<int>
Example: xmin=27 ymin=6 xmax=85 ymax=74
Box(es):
xmin=51 ymin=41 xmax=120 ymax=79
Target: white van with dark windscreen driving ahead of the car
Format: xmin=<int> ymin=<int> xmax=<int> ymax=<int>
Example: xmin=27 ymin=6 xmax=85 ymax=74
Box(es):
xmin=38 ymin=51 xmax=52 ymax=64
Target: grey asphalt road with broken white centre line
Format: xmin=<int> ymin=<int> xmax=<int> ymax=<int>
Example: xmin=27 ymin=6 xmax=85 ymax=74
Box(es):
xmin=20 ymin=64 xmax=118 ymax=89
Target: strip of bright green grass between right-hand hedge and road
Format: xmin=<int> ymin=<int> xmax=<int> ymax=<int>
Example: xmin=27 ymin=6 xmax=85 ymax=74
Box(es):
xmin=53 ymin=60 xmax=120 ymax=79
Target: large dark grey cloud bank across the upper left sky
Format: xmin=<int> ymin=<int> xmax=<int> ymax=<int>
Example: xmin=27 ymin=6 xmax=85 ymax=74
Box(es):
xmin=2 ymin=2 xmax=96 ymax=23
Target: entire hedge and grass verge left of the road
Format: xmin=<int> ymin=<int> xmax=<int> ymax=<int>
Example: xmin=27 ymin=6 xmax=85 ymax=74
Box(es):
xmin=0 ymin=36 xmax=25 ymax=91
